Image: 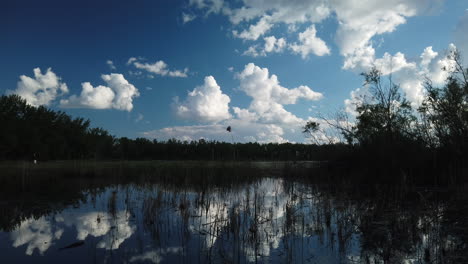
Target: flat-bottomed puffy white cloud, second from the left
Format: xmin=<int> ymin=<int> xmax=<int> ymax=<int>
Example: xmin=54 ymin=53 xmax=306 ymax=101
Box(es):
xmin=60 ymin=73 xmax=140 ymax=111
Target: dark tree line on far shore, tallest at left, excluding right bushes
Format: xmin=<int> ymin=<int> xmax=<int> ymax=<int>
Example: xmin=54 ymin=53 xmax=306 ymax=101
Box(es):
xmin=0 ymin=95 xmax=346 ymax=160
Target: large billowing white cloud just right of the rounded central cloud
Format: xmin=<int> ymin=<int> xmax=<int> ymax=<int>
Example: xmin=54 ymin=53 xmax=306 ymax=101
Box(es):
xmin=237 ymin=63 xmax=323 ymax=123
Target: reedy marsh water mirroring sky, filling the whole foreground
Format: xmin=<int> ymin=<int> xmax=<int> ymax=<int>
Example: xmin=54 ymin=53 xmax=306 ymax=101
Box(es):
xmin=0 ymin=162 xmax=468 ymax=263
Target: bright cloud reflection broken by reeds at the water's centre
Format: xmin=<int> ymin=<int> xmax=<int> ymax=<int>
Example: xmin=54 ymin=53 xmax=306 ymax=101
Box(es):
xmin=190 ymin=179 xmax=288 ymax=262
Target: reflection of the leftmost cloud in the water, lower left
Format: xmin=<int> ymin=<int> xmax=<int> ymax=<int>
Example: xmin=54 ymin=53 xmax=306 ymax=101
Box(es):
xmin=10 ymin=217 xmax=63 ymax=255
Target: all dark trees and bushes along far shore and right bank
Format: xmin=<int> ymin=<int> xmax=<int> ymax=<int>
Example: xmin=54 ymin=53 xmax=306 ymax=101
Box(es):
xmin=0 ymin=48 xmax=468 ymax=184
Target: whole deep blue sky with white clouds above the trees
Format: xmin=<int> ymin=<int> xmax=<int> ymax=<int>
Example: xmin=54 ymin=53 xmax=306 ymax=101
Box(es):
xmin=0 ymin=0 xmax=468 ymax=142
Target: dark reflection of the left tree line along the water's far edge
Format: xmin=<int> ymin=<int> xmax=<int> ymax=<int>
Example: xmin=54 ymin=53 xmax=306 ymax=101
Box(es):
xmin=0 ymin=161 xmax=262 ymax=231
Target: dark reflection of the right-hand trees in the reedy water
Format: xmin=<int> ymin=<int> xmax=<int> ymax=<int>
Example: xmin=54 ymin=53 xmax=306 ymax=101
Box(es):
xmin=310 ymin=186 xmax=468 ymax=263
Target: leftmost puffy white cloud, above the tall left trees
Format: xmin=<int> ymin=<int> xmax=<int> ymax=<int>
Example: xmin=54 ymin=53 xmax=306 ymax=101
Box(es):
xmin=6 ymin=68 xmax=68 ymax=106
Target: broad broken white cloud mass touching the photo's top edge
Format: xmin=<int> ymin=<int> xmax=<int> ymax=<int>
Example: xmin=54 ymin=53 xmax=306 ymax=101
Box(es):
xmin=191 ymin=0 xmax=440 ymax=61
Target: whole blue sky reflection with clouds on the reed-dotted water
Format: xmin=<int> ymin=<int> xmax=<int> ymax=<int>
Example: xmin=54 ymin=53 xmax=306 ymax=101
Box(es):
xmin=0 ymin=179 xmax=450 ymax=263
